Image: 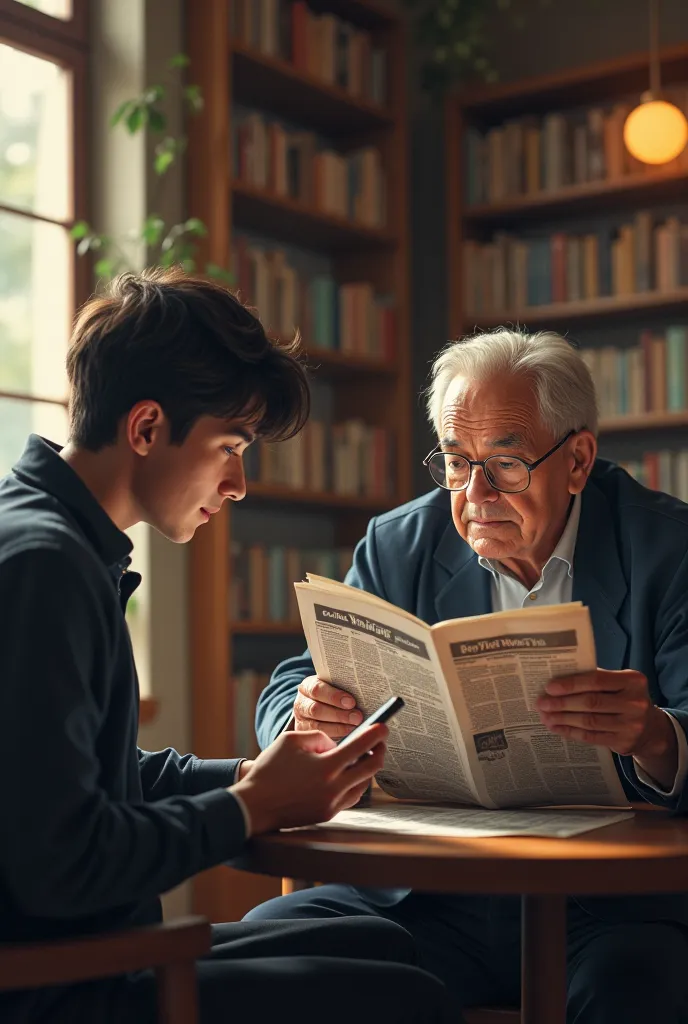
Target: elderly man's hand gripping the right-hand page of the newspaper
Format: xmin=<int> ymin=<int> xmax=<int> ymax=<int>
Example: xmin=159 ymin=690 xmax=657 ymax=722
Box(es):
xmin=536 ymin=669 xmax=678 ymax=790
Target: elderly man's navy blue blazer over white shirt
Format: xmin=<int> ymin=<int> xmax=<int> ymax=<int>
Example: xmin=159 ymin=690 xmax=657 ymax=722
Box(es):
xmin=256 ymin=459 xmax=688 ymax=920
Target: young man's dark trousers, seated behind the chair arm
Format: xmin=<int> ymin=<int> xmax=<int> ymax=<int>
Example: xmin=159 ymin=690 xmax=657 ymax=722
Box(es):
xmin=13 ymin=915 xmax=457 ymax=1024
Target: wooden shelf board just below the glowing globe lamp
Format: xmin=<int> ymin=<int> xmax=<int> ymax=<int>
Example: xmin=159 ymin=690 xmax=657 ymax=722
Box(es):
xmin=464 ymin=170 xmax=688 ymax=226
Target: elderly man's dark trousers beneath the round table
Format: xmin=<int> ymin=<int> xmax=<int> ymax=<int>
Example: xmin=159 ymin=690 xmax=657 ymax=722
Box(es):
xmin=245 ymin=885 xmax=688 ymax=1024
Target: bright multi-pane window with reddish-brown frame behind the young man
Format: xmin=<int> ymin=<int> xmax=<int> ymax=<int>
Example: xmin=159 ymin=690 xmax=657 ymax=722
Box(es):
xmin=0 ymin=0 xmax=88 ymax=475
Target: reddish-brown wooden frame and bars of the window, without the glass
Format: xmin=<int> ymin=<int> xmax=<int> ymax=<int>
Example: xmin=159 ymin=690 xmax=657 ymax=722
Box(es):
xmin=0 ymin=0 xmax=92 ymax=415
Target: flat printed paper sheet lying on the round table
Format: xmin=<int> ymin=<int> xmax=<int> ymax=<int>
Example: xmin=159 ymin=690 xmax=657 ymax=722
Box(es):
xmin=317 ymin=802 xmax=633 ymax=839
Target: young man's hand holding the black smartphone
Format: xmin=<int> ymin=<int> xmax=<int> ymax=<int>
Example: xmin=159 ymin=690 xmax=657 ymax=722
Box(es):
xmin=229 ymin=725 xmax=388 ymax=836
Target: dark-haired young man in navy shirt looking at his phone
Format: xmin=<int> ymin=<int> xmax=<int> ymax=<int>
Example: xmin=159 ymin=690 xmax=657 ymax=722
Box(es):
xmin=0 ymin=270 xmax=448 ymax=1024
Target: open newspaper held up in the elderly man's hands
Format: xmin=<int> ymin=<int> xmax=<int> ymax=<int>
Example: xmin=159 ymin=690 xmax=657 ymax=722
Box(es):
xmin=295 ymin=573 xmax=629 ymax=809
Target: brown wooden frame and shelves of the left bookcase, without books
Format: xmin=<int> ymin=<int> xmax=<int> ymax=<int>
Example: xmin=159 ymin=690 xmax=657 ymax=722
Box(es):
xmin=186 ymin=0 xmax=412 ymax=921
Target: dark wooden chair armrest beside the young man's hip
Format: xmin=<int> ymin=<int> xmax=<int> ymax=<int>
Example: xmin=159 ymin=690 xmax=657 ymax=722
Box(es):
xmin=0 ymin=918 xmax=211 ymax=1024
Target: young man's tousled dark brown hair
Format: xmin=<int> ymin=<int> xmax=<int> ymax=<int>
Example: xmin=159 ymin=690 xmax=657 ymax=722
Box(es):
xmin=67 ymin=267 xmax=310 ymax=452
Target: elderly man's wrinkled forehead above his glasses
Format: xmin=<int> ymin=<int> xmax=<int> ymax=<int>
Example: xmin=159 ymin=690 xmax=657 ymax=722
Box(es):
xmin=438 ymin=376 xmax=549 ymax=444
